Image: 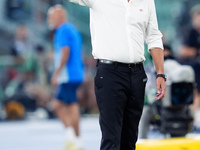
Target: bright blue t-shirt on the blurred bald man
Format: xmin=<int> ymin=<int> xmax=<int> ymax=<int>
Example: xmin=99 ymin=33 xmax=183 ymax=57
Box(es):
xmin=54 ymin=23 xmax=84 ymax=84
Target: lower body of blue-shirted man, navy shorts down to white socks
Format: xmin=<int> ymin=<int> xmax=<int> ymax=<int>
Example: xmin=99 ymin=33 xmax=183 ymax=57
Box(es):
xmin=54 ymin=83 xmax=82 ymax=149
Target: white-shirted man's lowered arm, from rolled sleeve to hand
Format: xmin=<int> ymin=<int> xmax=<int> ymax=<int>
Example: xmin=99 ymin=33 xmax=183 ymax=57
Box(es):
xmin=146 ymin=0 xmax=166 ymax=100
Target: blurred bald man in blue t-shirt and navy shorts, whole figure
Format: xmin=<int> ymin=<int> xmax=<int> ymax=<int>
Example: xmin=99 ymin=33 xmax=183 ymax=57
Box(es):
xmin=48 ymin=5 xmax=84 ymax=147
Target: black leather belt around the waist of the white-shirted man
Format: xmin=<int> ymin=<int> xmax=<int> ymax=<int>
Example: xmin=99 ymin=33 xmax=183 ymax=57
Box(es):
xmin=97 ymin=59 xmax=143 ymax=68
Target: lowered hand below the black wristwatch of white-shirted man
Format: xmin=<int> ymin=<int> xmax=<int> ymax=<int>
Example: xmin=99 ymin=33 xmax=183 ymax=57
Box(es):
xmin=156 ymin=77 xmax=166 ymax=100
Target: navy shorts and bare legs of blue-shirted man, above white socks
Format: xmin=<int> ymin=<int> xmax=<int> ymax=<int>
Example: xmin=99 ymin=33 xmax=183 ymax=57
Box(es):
xmin=53 ymin=82 xmax=80 ymax=136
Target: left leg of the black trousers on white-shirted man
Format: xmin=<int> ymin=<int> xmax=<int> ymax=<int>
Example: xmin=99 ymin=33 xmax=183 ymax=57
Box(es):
xmin=95 ymin=64 xmax=130 ymax=150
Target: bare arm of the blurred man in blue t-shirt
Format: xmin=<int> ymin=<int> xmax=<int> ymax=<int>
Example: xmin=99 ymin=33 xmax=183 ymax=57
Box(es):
xmin=52 ymin=46 xmax=70 ymax=87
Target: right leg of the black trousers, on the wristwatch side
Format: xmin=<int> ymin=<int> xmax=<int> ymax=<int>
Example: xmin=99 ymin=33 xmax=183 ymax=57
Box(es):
xmin=120 ymin=67 xmax=147 ymax=150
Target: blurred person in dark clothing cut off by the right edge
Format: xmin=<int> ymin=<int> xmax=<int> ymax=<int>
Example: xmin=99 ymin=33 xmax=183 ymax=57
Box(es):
xmin=179 ymin=5 xmax=200 ymax=110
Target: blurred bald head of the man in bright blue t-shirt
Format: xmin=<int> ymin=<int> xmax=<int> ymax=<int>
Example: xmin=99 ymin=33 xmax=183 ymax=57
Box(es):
xmin=48 ymin=5 xmax=67 ymax=29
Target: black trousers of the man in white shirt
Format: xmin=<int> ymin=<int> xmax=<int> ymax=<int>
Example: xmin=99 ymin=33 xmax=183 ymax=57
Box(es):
xmin=95 ymin=63 xmax=147 ymax=150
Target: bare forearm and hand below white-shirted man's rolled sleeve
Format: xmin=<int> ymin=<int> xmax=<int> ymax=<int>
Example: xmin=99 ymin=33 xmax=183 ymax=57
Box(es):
xmin=150 ymin=48 xmax=166 ymax=100
